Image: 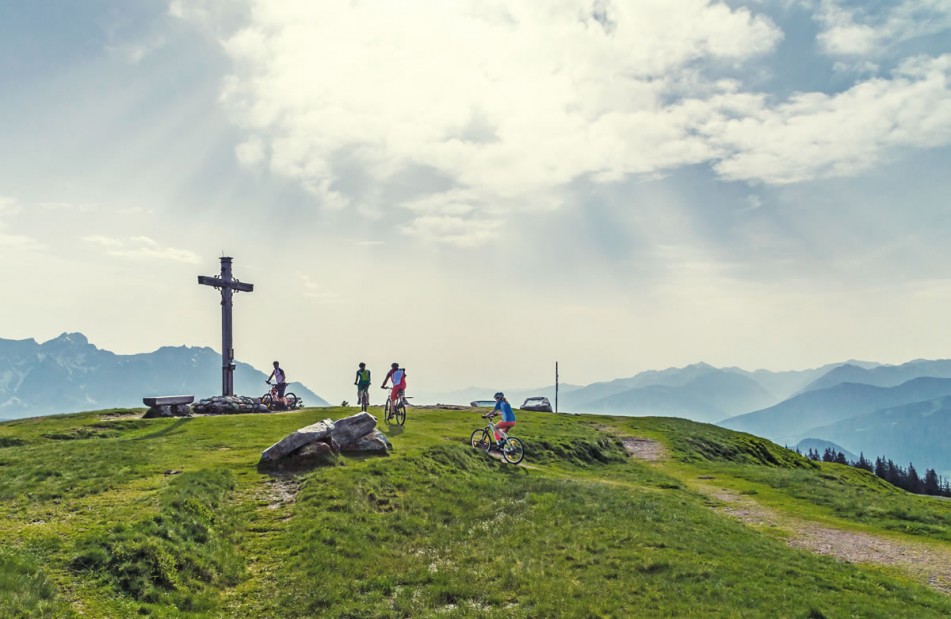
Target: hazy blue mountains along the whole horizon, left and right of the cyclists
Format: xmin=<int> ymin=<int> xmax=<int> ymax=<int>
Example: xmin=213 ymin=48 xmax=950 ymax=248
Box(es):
xmin=9 ymin=333 xmax=951 ymax=476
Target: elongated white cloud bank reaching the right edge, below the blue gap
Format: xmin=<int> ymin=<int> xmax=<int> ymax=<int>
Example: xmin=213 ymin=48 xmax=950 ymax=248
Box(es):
xmin=706 ymin=55 xmax=951 ymax=184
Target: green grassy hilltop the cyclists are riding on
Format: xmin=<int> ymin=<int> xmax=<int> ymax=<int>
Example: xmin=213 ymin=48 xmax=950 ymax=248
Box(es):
xmin=0 ymin=409 xmax=951 ymax=618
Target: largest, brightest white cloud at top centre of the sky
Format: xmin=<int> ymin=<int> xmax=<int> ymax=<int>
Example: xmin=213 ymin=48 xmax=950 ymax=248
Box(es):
xmin=195 ymin=0 xmax=782 ymax=237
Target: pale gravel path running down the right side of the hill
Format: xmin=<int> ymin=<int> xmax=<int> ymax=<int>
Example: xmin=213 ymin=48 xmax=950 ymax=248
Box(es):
xmin=623 ymin=437 xmax=951 ymax=595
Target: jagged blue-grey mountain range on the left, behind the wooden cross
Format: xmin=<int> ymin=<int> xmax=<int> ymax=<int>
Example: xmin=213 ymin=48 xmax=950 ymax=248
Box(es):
xmin=0 ymin=333 xmax=327 ymax=419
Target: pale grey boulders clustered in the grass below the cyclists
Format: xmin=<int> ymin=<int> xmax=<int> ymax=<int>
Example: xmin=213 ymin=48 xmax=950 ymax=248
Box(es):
xmin=258 ymin=413 xmax=392 ymax=469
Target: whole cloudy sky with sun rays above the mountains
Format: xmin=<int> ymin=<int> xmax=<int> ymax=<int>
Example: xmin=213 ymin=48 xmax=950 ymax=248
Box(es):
xmin=0 ymin=0 xmax=951 ymax=401
